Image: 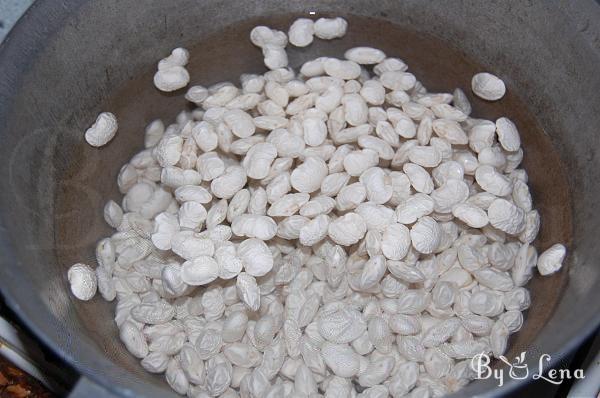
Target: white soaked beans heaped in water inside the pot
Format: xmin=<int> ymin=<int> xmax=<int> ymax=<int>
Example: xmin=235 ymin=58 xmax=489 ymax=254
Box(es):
xmin=68 ymin=18 xmax=566 ymax=398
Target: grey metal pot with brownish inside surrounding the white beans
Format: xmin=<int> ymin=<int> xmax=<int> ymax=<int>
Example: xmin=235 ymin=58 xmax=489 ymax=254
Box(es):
xmin=0 ymin=0 xmax=600 ymax=397
